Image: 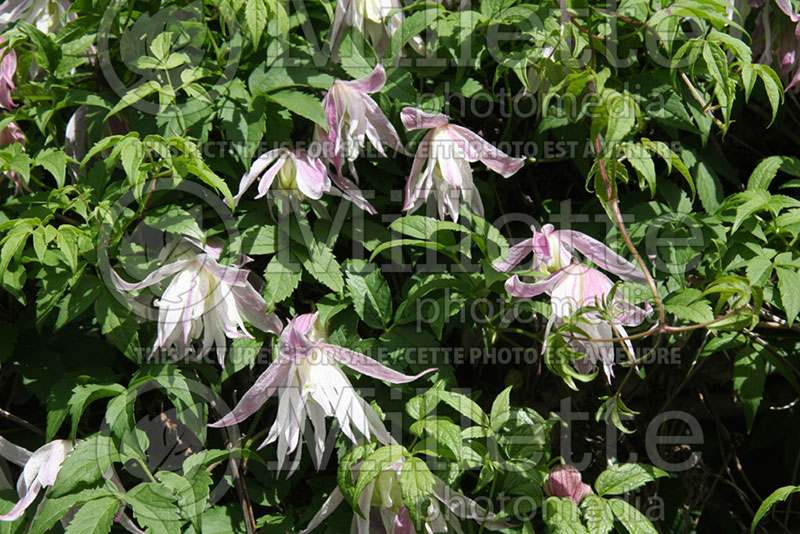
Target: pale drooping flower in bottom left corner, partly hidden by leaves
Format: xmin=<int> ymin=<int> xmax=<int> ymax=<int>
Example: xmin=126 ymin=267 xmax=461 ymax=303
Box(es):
xmin=0 ymin=436 xmax=144 ymax=534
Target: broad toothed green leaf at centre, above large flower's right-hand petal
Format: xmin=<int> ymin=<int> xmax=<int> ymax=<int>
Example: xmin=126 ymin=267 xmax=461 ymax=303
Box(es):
xmin=346 ymin=264 xmax=392 ymax=329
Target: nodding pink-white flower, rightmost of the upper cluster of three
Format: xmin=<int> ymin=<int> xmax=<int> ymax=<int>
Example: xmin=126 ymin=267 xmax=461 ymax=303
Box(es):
xmin=400 ymin=107 xmax=524 ymax=221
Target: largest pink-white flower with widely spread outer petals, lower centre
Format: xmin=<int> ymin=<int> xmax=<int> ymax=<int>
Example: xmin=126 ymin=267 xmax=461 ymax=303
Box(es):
xmin=209 ymin=313 xmax=434 ymax=470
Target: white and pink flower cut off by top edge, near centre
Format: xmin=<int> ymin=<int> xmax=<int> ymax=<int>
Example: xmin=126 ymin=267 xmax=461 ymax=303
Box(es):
xmin=329 ymin=0 xmax=425 ymax=61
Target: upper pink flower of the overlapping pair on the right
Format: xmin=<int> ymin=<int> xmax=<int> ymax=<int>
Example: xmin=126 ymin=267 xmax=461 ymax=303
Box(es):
xmin=492 ymin=224 xmax=647 ymax=283
